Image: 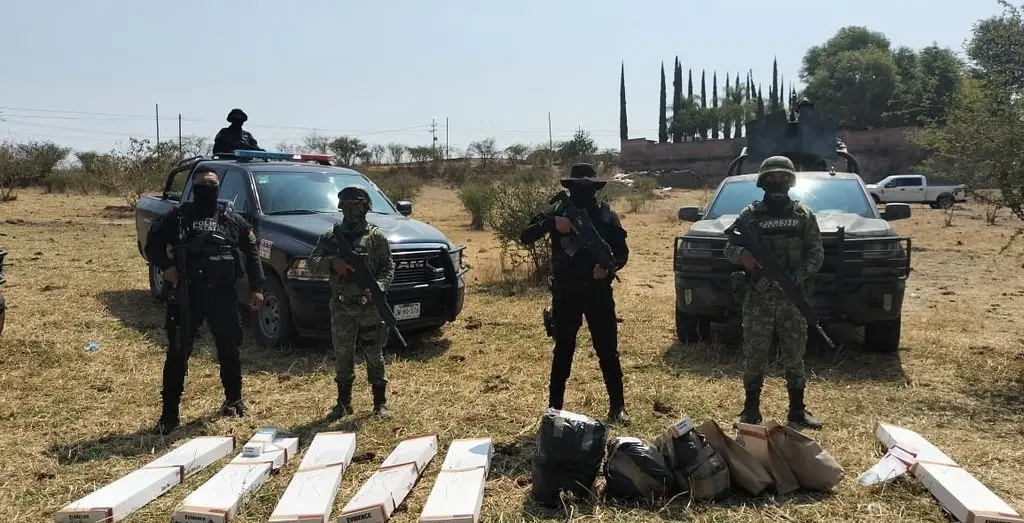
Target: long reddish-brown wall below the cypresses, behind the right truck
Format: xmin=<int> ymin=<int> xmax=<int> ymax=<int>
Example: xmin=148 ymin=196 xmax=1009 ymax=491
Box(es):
xmin=620 ymin=127 xmax=922 ymax=188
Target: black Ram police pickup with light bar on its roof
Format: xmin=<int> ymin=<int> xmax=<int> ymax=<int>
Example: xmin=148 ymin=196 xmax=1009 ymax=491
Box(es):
xmin=135 ymin=152 xmax=468 ymax=346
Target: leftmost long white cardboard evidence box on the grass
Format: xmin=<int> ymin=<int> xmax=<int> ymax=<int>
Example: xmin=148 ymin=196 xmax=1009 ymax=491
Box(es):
xmin=54 ymin=436 xmax=234 ymax=523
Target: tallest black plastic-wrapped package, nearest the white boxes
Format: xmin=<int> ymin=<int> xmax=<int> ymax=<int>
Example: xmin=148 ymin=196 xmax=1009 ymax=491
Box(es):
xmin=532 ymin=408 xmax=607 ymax=507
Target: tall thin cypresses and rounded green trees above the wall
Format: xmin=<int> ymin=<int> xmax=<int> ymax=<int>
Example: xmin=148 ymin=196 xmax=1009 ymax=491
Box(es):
xmin=620 ymin=26 xmax=968 ymax=143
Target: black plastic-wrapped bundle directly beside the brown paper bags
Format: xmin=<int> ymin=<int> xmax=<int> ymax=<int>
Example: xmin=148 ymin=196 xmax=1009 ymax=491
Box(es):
xmin=654 ymin=417 xmax=731 ymax=500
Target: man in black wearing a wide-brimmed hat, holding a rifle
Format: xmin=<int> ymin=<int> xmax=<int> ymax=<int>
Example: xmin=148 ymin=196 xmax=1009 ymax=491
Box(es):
xmin=519 ymin=164 xmax=630 ymax=424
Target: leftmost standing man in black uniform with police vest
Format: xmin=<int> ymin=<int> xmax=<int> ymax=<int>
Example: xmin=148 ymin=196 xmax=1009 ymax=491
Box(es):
xmin=145 ymin=166 xmax=263 ymax=434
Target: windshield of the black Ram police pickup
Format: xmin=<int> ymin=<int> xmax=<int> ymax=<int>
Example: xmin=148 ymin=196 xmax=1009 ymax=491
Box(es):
xmin=253 ymin=171 xmax=395 ymax=214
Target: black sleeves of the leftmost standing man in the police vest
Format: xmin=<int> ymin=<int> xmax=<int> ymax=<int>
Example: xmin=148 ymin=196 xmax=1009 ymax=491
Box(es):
xmin=145 ymin=202 xmax=265 ymax=292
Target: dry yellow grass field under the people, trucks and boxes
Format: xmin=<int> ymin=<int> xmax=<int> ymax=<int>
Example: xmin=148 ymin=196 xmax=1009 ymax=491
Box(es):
xmin=0 ymin=182 xmax=1024 ymax=523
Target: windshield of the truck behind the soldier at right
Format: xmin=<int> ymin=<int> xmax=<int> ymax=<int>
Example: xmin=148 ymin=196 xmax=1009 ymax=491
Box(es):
xmin=705 ymin=178 xmax=877 ymax=220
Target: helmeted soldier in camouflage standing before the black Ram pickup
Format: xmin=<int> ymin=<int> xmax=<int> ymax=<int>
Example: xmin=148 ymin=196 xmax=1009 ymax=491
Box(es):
xmin=307 ymin=185 xmax=394 ymax=421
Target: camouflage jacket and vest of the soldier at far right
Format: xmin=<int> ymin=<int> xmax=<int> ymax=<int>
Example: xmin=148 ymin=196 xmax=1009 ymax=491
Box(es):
xmin=725 ymin=202 xmax=824 ymax=292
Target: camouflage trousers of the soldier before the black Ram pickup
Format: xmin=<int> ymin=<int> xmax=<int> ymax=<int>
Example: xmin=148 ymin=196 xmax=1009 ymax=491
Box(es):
xmin=331 ymin=298 xmax=388 ymax=387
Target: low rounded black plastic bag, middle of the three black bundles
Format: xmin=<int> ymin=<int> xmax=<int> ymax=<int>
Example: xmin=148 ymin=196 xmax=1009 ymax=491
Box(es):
xmin=604 ymin=437 xmax=676 ymax=500
